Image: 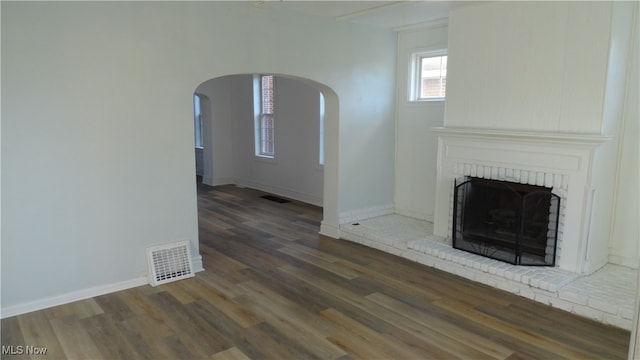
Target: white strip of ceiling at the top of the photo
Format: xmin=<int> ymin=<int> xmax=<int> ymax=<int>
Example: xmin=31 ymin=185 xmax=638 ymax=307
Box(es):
xmin=254 ymin=0 xmax=460 ymax=30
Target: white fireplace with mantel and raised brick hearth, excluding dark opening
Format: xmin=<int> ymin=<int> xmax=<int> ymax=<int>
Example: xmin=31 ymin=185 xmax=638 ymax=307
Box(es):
xmin=340 ymin=127 xmax=637 ymax=329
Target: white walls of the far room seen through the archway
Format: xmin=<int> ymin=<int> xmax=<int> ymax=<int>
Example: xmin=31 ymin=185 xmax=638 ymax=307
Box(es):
xmin=196 ymin=75 xmax=323 ymax=206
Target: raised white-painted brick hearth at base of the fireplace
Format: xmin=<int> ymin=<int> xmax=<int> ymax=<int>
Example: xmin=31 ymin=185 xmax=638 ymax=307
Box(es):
xmin=340 ymin=214 xmax=638 ymax=330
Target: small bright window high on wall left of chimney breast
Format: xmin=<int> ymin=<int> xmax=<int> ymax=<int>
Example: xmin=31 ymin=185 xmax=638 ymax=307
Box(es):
xmin=410 ymin=52 xmax=447 ymax=101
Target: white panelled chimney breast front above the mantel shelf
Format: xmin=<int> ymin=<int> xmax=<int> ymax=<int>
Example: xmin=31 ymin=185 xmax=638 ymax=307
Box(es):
xmin=445 ymin=1 xmax=612 ymax=133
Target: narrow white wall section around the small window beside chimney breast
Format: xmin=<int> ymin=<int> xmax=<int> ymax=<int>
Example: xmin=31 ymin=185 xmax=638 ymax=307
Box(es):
xmin=394 ymin=22 xmax=447 ymax=221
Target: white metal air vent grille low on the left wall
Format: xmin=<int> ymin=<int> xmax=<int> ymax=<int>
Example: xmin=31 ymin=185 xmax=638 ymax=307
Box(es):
xmin=147 ymin=241 xmax=193 ymax=286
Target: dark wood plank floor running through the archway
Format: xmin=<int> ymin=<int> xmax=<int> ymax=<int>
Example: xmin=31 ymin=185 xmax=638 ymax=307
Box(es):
xmin=2 ymin=186 xmax=629 ymax=360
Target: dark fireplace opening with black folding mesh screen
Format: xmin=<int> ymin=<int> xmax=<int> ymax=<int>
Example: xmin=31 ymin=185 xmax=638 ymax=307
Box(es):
xmin=452 ymin=177 xmax=560 ymax=266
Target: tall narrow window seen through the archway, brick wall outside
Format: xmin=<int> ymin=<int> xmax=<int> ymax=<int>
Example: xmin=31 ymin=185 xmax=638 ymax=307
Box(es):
xmin=254 ymin=75 xmax=275 ymax=158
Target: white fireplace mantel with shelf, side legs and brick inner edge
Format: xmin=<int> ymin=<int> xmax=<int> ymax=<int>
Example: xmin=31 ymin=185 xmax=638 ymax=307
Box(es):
xmin=432 ymin=127 xmax=610 ymax=273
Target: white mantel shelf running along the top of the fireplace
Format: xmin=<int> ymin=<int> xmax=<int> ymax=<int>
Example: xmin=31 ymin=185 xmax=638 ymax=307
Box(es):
xmin=431 ymin=127 xmax=611 ymax=147
